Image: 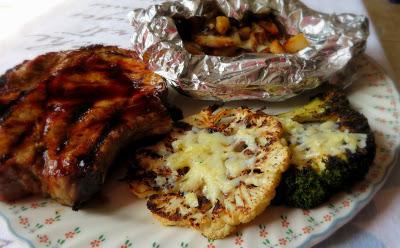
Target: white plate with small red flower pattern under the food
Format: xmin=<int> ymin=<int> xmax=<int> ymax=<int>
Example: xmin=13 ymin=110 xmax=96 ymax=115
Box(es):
xmin=0 ymin=54 xmax=400 ymax=248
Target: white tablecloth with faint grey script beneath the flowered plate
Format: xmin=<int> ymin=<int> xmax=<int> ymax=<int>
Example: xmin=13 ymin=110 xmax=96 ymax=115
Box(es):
xmin=0 ymin=0 xmax=400 ymax=248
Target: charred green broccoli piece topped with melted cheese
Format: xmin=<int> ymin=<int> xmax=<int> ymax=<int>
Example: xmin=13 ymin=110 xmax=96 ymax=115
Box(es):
xmin=274 ymin=90 xmax=376 ymax=209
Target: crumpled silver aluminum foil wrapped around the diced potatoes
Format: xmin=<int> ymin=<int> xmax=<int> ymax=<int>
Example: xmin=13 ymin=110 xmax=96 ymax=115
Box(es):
xmin=129 ymin=0 xmax=369 ymax=101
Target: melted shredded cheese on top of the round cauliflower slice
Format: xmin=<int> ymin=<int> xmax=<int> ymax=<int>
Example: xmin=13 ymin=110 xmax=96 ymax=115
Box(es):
xmin=166 ymin=128 xmax=259 ymax=203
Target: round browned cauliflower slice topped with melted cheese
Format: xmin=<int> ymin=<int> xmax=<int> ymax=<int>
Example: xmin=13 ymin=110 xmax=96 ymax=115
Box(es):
xmin=130 ymin=107 xmax=289 ymax=239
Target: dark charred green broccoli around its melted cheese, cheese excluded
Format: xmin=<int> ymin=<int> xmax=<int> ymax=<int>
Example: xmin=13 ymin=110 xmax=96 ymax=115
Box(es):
xmin=274 ymin=90 xmax=376 ymax=209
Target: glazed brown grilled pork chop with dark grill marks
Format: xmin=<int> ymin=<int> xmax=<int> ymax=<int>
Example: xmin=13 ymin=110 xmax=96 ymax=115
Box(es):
xmin=0 ymin=46 xmax=171 ymax=207
